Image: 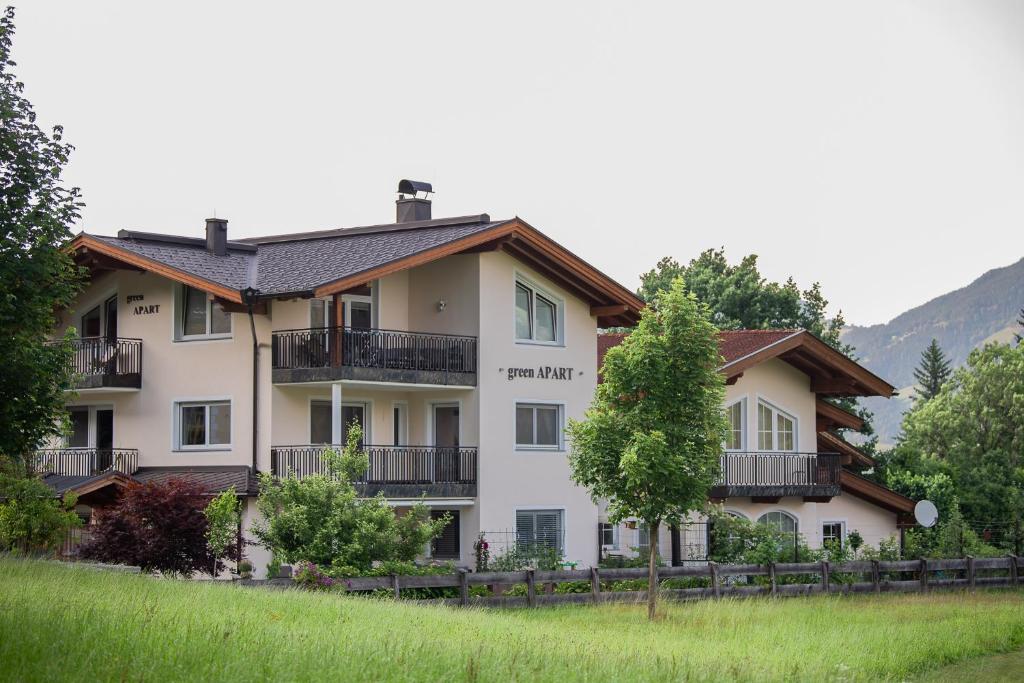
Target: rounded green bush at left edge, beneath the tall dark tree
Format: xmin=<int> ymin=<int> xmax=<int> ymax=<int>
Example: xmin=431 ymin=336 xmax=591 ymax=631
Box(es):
xmin=0 ymin=474 xmax=82 ymax=553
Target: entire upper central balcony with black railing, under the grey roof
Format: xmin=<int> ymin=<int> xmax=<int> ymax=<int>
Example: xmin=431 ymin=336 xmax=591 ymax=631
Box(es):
xmin=271 ymin=328 xmax=476 ymax=386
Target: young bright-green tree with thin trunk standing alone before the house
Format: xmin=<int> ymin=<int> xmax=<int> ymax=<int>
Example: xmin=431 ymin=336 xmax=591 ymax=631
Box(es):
xmin=567 ymin=278 xmax=726 ymax=618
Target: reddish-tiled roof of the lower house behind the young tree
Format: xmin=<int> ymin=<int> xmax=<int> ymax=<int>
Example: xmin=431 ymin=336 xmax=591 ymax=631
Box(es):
xmin=597 ymin=330 xmax=895 ymax=401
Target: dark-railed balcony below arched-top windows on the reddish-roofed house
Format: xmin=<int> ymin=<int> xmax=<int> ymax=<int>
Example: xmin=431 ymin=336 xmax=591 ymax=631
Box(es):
xmin=711 ymin=452 xmax=842 ymax=502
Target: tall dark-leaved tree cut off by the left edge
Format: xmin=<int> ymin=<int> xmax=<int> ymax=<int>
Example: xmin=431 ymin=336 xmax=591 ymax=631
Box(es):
xmin=0 ymin=7 xmax=82 ymax=460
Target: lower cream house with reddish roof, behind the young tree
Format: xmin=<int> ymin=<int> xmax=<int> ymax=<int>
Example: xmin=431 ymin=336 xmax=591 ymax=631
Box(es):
xmin=598 ymin=330 xmax=914 ymax=562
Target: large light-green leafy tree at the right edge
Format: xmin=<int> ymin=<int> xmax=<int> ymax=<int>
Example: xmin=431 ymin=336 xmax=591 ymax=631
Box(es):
xmin=899 ymin=344 xmax=1024 ymax=548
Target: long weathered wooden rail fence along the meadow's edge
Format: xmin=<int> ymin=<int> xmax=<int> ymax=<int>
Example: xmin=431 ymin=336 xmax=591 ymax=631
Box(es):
xmin=329 ymin=555 xmax=1021 ymax=607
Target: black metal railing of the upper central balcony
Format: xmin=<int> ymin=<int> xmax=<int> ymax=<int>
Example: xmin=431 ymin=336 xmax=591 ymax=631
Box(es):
xmin=272 ymin=328 xmax=476 ymax=374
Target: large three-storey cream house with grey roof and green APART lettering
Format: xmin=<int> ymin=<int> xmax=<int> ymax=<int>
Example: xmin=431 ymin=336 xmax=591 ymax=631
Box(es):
xmin=37 ymin=181 xmax=642 ymax=571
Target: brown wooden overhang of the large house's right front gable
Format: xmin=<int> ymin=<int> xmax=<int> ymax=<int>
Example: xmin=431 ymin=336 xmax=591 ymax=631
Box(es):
xmin=313 ymin=218 xmax=644 ymax=327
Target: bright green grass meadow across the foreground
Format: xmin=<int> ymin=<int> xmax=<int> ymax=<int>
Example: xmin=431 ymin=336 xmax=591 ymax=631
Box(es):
xmin=0 ymin=559 xmax=1024 ymax=681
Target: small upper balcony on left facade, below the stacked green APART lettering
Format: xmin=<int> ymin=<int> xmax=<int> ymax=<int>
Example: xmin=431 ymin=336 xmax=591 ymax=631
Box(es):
xmin=54 ymin=337 xmax=142 ymax=389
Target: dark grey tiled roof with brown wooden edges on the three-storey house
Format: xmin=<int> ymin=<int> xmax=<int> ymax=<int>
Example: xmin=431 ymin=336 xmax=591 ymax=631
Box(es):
xmin=71 ymin=214 xmax=644 ymax=326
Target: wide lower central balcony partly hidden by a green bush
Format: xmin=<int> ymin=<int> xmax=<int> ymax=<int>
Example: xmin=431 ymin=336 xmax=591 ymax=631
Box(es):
xmin=270 ymin=445 xmax=476 ymax=498
